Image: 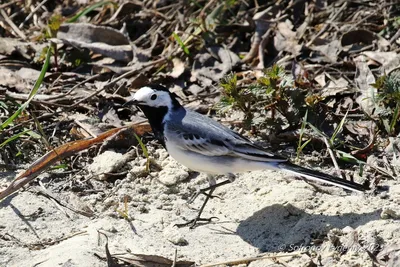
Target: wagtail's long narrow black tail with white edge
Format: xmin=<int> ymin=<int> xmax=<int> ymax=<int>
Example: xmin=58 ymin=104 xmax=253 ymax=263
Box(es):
xmin=277 ymin=162 xmax=368 ymax=192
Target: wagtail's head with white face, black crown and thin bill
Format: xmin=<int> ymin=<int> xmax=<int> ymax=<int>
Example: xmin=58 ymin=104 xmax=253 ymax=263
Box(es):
xmin=125 ymin=85 xmax=181 ymax=110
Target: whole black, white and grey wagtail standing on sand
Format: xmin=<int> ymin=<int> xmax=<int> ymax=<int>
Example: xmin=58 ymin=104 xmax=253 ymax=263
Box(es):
xmin=125 ymin=85 xmax=366 ymax=227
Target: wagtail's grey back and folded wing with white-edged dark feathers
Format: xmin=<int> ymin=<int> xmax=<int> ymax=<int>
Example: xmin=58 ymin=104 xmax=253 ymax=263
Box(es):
xmin=168 ymin=111 xmax=287 ymax=162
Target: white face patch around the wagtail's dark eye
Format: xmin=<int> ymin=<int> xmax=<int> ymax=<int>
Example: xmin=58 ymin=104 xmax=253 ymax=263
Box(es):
xmin=133 ymin=86 xmax=173 ymax=108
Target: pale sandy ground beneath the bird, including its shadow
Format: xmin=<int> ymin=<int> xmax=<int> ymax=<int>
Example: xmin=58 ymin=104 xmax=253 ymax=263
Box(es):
xmin=0 ymin=150 xmax=400 ymax=267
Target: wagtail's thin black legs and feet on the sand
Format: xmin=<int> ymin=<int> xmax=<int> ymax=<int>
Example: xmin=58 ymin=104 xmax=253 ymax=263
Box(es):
xmin=176 ymin=174 xmax=235 ymax=229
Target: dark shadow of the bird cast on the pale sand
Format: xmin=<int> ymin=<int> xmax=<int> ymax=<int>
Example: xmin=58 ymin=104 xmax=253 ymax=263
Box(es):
xmin=236 ymin=204 xmax=380 ymax=252
